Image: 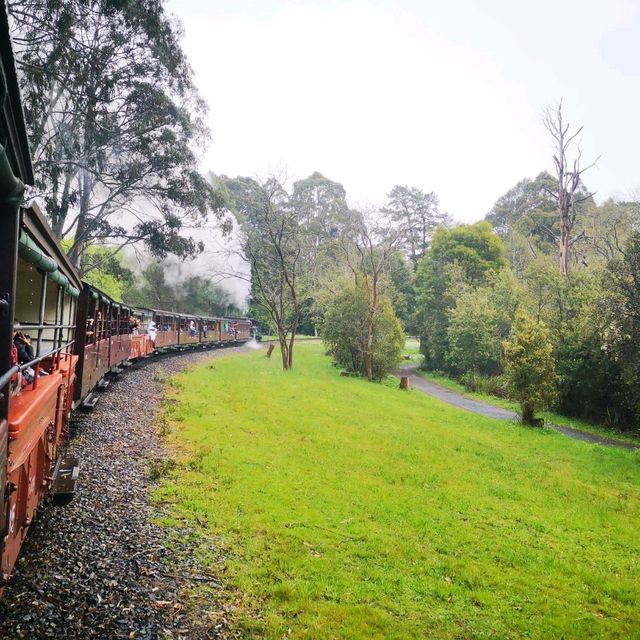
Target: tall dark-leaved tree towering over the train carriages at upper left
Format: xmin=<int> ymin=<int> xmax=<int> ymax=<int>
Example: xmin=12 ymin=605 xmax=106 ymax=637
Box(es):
xmin=9 ymin=0 xmax=223 ymax=272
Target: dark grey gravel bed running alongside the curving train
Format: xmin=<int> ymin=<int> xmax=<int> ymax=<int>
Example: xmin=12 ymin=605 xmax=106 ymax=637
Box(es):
xmin=0 ymin=348 xmax=250 ymax=640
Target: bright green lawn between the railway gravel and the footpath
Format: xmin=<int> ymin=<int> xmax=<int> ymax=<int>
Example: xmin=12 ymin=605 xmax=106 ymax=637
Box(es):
xmin=157 ymin=342 xmax=640 ymax=640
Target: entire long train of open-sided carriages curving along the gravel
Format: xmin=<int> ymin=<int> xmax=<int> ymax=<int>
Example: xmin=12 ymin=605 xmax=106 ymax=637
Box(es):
xmin=0 ymin=2 xmax=251 ymax=595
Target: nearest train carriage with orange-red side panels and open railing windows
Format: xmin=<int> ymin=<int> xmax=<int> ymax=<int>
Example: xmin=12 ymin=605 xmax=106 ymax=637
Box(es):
xmin=0 ymin=21 xmax=81 ymax=590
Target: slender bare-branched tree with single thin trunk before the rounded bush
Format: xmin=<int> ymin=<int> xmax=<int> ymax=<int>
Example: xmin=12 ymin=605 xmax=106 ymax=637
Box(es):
xmin=341 ymin=210 xmax=406 ymax=380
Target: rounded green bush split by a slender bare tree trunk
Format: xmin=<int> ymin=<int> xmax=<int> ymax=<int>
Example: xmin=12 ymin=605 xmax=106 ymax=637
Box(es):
xmin=320 ymin=280 xmax=404 ymax=380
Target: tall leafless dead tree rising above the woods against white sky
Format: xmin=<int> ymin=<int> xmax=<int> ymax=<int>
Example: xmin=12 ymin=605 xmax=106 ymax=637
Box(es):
xmin=542 ymin=100 xmax=598 ymax=280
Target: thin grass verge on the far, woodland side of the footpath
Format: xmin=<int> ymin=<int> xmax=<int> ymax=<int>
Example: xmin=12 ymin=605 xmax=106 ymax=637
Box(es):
xmin=404 ymin=340 xmax=640 ymax=444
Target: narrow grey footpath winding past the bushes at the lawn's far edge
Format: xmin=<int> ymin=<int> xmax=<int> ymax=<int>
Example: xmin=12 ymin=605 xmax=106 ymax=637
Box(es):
xmin=398 ymin=364 xmax=640 ymax=450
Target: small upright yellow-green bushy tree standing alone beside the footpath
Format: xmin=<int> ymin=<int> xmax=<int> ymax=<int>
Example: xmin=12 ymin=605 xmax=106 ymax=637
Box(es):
xmin=504 ymin=311 xmax=557 ymax=424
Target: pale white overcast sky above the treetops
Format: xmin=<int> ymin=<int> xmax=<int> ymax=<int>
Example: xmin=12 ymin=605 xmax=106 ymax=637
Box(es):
xmin=168 ymin=0 xmax=640 ymax=221
